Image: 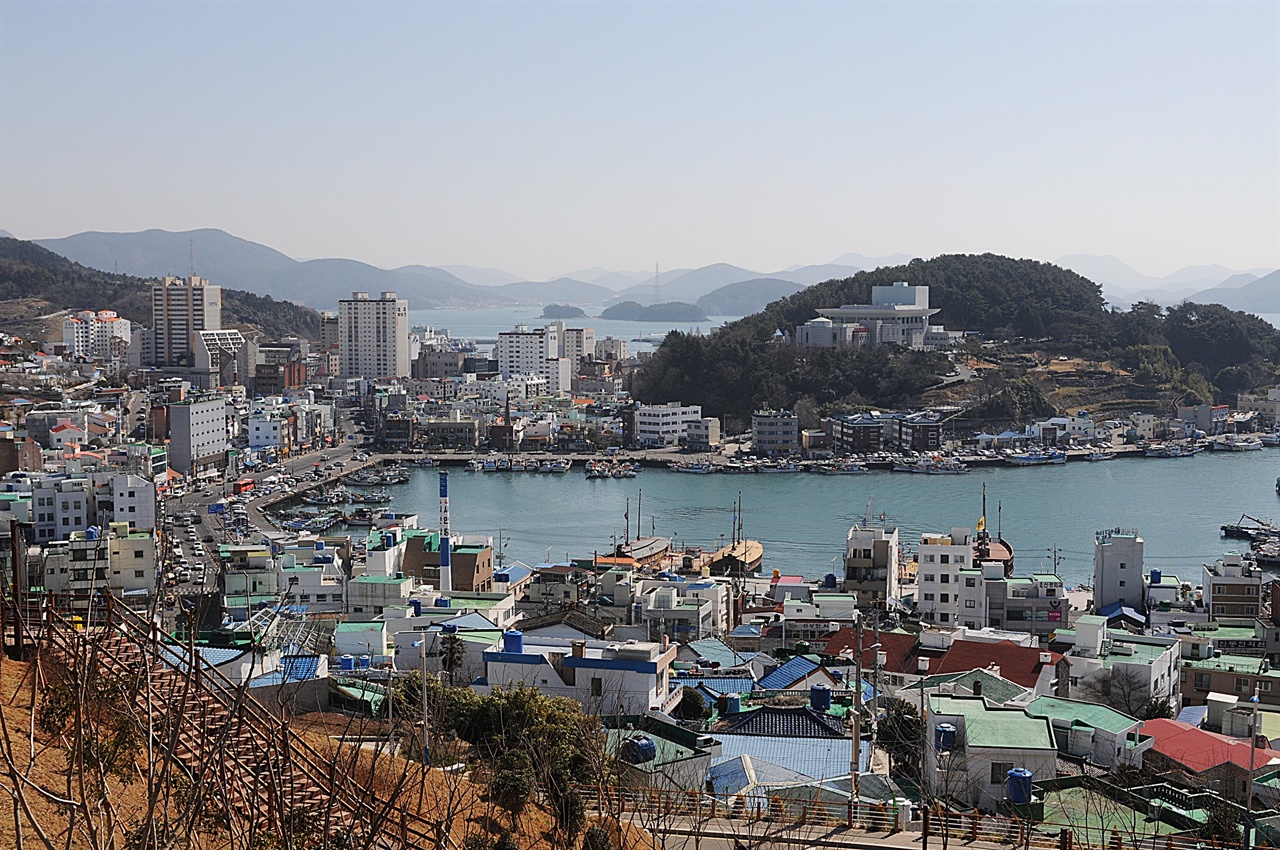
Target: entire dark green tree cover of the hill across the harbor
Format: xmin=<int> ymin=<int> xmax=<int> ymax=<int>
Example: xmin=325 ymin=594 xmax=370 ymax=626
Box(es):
xmin=632 ymin=253 xmax=1280 ymax=421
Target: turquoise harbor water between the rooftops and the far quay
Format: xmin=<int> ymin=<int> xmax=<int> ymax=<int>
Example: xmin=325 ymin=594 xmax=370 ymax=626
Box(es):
xmin=381 ymin=449 xmax=1280 ymax=585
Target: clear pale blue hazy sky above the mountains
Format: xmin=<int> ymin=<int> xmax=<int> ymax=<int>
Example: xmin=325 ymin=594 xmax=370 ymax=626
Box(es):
xmin=0 ymin=0 xmax=1280 ymax=278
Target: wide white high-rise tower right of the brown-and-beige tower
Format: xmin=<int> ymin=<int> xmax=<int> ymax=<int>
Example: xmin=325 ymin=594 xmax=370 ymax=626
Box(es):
xmin=338 ymin=292 xmax=411 ymax=378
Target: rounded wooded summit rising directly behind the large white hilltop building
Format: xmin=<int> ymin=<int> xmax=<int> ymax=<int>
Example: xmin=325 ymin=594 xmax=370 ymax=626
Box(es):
xmin=730 ymin=253 xmax=1106 ymax=339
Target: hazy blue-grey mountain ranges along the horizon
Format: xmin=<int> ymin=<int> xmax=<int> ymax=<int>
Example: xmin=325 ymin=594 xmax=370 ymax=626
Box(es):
xmin=36 ymin=229 xmax=1280 ymax=315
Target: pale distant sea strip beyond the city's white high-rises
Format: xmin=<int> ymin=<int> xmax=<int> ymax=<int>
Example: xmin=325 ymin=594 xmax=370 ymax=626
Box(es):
xmin=408 ymin=307 xmax=740 ymax=352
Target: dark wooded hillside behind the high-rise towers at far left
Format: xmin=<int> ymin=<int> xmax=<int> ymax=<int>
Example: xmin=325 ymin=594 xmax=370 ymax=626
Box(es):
xmin=0 ymin=238 xmax=320 ymax=339
